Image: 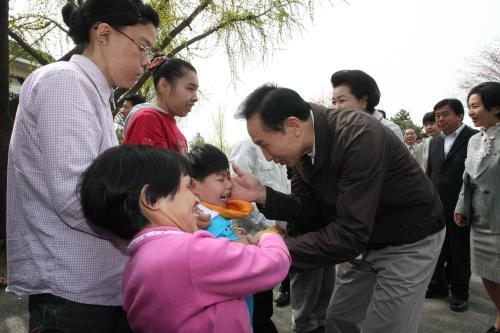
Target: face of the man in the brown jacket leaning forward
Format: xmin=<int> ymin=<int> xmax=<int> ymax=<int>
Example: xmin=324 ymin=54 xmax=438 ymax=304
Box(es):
xmin=247 ymin=113 xmax=304 ymax=166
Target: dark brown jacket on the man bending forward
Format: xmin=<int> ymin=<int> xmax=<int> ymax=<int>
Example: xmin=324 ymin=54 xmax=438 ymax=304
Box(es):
xmin=261 ymin=105 xmax=444 ymax=269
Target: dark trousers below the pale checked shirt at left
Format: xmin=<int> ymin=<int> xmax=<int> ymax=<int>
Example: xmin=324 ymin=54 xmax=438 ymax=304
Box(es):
xmin=28 ymin=294 xmax=132 ymax=333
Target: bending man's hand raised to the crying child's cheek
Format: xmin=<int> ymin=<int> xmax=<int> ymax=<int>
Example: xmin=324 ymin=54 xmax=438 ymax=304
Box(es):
xmin=231 ymin=163 xmax=266 ymax=205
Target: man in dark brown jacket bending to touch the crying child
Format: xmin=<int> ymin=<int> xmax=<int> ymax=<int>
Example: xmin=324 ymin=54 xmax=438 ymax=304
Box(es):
xmin=232 ymin=85 xmax=445 ymax=333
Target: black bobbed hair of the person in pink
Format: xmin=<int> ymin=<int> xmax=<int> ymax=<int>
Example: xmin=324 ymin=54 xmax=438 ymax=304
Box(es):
xmin=80 ymin=145 xmax=189 ymax=240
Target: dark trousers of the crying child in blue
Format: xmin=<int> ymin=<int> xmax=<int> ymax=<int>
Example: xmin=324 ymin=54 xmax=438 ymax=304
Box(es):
xmin=252 ymin=290 xmax=278 ymax=333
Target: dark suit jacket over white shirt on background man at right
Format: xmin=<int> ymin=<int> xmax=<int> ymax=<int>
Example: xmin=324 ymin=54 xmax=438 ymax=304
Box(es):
xmin=427 ymin=126 xmax=478 ymax=218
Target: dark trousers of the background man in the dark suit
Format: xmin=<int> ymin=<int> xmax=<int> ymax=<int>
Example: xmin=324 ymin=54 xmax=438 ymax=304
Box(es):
xmin=429 ymin=219 xmax=471 ymax=300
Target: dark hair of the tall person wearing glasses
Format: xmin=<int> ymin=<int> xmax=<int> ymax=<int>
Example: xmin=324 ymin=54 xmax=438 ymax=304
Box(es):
xmin=62 ymin=0 xmax=160 ymax=45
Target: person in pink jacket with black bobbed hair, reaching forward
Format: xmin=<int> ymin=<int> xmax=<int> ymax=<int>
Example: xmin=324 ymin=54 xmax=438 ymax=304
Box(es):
xmin=80 ymin=146 xmax=291 ymax=333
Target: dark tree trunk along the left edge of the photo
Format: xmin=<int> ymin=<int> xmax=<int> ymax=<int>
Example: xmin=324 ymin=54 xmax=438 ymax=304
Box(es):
xmin=0 ymin=0 xmax=12 ymax=239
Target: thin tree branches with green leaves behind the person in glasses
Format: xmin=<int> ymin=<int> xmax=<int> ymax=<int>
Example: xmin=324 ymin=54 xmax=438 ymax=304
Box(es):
xmin=9 ymin=0 xmax=322 ymax=105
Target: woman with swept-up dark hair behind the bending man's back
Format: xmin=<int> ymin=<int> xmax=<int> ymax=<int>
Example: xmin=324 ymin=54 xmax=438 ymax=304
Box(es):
xmin=330 ymin=70 xmax=403 ymax=141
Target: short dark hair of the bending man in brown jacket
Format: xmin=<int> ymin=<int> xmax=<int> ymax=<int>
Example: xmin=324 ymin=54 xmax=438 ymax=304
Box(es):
xmin=235 ymin=84 xmax=311 ymax=132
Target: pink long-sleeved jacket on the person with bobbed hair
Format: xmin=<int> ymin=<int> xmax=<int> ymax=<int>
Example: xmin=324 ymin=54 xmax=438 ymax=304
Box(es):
xmin=123 ymin=227 xmax=291 ymax=333
